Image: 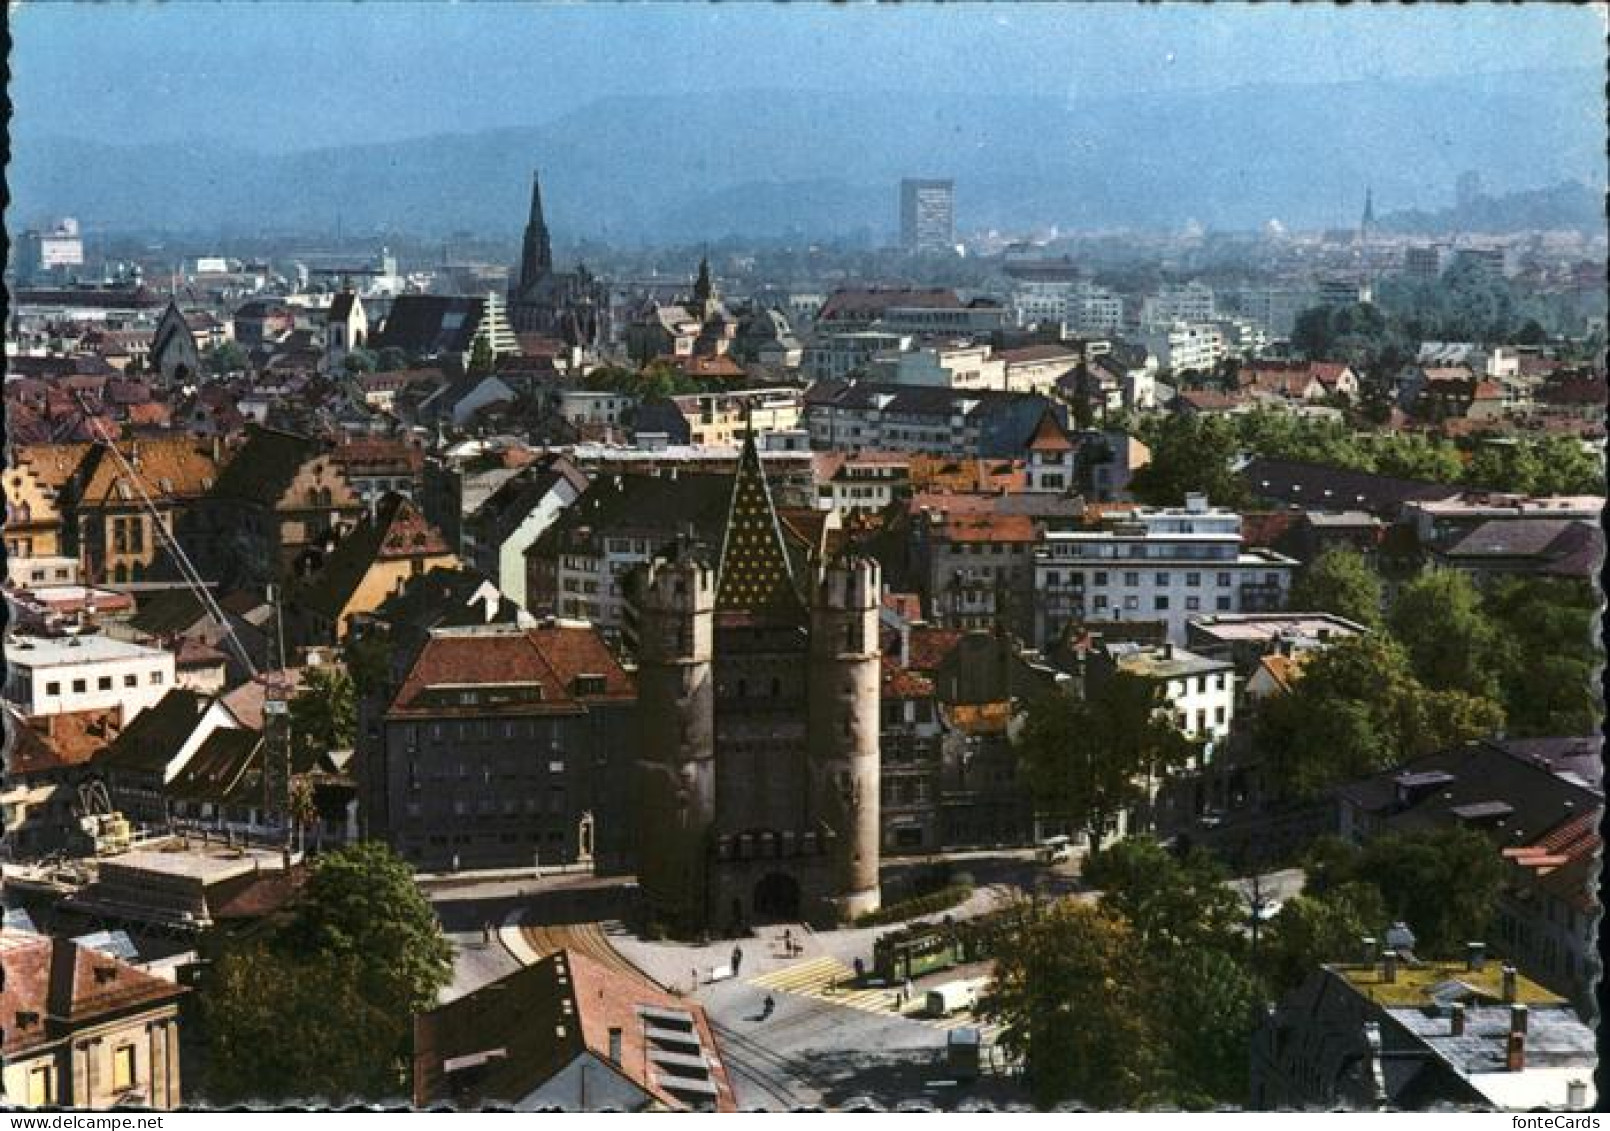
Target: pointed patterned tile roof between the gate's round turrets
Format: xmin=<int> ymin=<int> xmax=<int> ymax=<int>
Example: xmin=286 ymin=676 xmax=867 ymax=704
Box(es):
xmin=715 ymin=429 xmax=805 ymax=620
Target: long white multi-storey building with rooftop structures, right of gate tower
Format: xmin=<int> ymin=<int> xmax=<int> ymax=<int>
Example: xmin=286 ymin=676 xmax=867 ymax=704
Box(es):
xmin=1034 ymin=495 xmax=1298 ymax=648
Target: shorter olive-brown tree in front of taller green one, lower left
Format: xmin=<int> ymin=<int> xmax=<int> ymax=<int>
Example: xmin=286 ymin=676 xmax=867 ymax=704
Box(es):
xmin=200 ymin=939 xmax=409 ymax=1104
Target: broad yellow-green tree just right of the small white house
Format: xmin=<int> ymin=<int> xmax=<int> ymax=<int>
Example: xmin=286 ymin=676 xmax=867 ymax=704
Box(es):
xmin=1254 ymin=633 xmax=1504 ymax=799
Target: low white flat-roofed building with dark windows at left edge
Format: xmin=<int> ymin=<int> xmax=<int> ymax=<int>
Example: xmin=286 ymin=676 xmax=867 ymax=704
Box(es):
xmin=5 ymin=635 xmax=174 ymax=725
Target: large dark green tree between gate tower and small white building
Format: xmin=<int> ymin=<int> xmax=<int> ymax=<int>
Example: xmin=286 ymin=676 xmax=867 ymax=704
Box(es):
xmin=1016 ymin=672 xmax=1193 ymax=854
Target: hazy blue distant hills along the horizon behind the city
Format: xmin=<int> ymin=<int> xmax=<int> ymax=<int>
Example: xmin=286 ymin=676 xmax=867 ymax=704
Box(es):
xmin=8 ymin=61 xmax=1605 ymax=242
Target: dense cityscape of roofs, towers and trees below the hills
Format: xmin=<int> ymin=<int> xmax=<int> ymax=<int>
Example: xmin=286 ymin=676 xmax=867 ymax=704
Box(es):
xmin=0 ymin=4 xmax=1610 ymax=1112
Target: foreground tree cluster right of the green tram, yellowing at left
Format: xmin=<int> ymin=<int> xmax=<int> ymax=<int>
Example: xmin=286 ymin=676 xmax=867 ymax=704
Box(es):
xmin=980 ymin=828 xmax=1502 ymax=1108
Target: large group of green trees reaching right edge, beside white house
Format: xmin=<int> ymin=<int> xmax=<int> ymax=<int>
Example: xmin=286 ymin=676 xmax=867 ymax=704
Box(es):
xmin=1275 ymin=549 xmax=1602 ymax=798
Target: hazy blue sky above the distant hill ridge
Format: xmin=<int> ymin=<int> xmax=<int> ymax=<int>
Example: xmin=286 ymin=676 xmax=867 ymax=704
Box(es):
xmin=11 ymin=2 xmax=1604 ymax=150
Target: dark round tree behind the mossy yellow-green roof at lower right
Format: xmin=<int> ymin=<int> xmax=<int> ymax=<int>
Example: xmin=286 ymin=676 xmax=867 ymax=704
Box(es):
xmin=1357 ymin=825 xmax=1504 ymax=959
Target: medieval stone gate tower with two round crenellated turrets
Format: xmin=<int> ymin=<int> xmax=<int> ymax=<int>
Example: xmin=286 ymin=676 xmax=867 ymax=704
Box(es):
xmin=628 ymin=440 xmax=882 ymax=934
